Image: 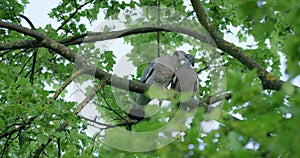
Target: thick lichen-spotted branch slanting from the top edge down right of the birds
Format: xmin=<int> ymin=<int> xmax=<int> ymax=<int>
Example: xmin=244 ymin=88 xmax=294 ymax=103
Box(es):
xmin=191 ymin=0 xmax=282 ymax=90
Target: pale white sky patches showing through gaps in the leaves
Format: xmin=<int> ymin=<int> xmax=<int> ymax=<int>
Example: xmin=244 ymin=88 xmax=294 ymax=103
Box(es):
xmin=22 ymin=0 xmax=300 ymax=133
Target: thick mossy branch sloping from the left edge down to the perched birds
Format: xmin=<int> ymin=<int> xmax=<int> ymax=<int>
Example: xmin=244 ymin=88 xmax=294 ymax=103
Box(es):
xmin=0 ymin=21 xmax=150 ymax=93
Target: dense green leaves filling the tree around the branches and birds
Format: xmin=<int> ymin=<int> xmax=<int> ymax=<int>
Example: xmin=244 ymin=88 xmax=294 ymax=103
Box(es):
xmin=0 ymin=0 xmax=300 ymax=158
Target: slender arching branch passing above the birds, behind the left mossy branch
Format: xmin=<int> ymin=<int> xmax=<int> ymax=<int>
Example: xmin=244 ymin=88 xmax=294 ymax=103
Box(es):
xmin=0 ymin=25 xmax=211 ymax=50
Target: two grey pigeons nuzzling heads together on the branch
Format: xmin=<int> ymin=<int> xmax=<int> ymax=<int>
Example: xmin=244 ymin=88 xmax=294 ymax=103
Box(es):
xmin=128 ymin=51 xmax=198 ymax=121
